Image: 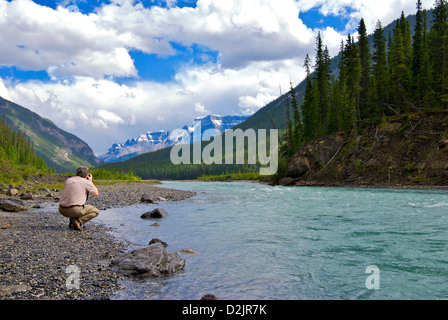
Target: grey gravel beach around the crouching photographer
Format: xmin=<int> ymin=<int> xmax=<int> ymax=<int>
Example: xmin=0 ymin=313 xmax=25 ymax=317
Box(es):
xmin=0 ymin=181 xmax=195 ymax=300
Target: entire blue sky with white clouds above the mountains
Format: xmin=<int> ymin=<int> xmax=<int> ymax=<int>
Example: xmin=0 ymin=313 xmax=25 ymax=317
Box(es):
xmin=0 ymin=0 xmax=434 ymax=154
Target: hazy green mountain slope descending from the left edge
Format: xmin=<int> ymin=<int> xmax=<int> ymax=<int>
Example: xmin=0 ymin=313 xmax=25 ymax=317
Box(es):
xmin=0 ymin=97 xmax=100 ymax=173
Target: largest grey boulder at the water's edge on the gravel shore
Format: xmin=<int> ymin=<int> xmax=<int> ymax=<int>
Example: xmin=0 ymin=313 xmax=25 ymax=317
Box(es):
xmin=111 ymin=242 xmax=185 ymax=277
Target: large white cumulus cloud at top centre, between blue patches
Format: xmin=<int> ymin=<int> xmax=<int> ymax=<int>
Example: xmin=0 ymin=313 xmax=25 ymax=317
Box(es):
xmin=93 ymin=0 xmax=314 ymax=68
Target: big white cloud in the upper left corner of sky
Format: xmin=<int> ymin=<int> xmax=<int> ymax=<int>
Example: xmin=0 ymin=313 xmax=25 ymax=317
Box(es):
xmin=0 ymin=0 xmax=136 ymax=77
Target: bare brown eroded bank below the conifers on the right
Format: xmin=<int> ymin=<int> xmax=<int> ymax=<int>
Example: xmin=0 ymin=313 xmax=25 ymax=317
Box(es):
xmin=279 ymin=112 xmax=448 ymax=187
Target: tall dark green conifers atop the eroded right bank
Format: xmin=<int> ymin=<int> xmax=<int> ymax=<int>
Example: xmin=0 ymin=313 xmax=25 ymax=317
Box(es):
xmin=282 ymin=0 xmax=448 ymax=156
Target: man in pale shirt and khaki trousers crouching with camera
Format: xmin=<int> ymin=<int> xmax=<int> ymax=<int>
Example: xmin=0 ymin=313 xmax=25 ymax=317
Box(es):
xmin=59 ymin=167 xmax=100 ymax=231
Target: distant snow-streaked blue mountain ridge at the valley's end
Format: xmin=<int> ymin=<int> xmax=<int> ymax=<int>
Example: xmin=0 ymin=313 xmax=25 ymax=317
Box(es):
xmin=98 ymin=115 xmax=249 ymax=163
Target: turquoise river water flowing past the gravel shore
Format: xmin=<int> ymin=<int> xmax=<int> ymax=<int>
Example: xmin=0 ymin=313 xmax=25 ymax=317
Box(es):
xmin=96 ymin=182 xmax=448 ymax=300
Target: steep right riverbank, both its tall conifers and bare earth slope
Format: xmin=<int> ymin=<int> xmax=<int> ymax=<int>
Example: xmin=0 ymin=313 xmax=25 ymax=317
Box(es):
xmin=278 ymin=0 xmax=448 ymax=186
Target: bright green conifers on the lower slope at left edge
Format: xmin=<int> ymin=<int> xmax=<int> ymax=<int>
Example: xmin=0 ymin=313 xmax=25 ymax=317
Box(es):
xmin=0 ymin=117 xmax=47 ymax=171
